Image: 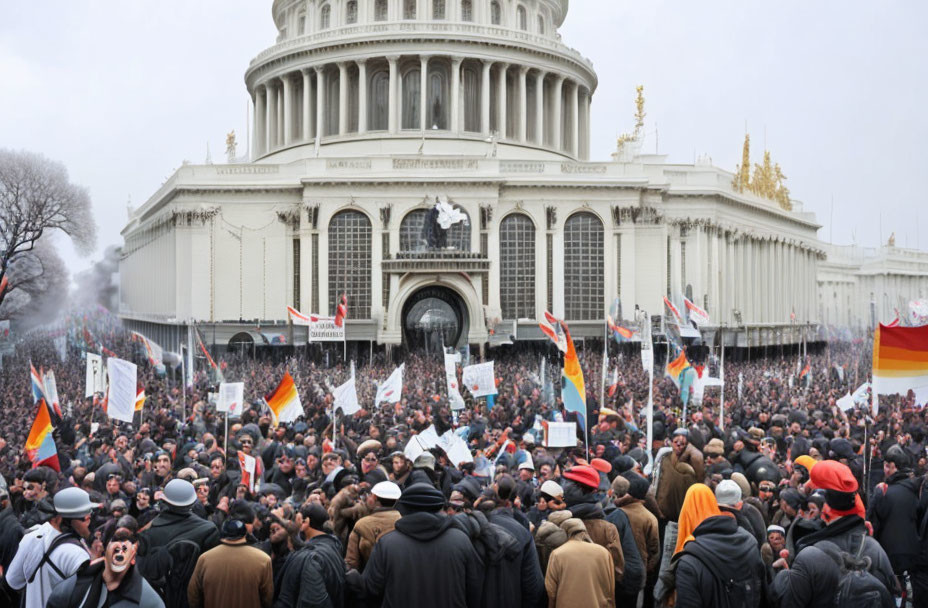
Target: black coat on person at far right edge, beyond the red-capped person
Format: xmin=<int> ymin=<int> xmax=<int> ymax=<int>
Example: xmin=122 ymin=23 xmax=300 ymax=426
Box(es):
xmin=867 ymin=471 xmax=921 ymax=574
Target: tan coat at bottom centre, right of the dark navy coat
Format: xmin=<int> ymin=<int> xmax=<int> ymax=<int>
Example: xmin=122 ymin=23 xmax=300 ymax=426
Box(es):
xmin=545 ymin=540 xmax=615 ymax=608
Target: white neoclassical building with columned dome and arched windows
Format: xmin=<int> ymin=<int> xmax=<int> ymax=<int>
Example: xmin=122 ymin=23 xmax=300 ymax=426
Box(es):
xmin=120 ymin=0 xmax=924 ymax=348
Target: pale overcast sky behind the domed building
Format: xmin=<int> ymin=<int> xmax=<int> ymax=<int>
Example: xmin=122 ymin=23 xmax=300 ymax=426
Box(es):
xmin=0 ymin=0 xmax=928 ymax=271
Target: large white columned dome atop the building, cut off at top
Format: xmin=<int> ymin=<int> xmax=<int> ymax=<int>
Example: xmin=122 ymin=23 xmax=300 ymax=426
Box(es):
xmin=245 ymin=0 xmax=597 ymax=162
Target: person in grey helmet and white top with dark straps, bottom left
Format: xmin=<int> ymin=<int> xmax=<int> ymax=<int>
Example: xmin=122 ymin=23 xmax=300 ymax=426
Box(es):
xmin=6 ymin=488 xmax=100 ymax=608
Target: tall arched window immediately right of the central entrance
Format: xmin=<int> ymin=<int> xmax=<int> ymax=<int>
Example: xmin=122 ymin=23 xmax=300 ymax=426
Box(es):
xmin=499 ymin=213 xmax=535 ymax=319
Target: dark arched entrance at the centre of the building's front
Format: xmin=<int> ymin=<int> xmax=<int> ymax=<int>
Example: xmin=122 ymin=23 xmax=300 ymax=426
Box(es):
xmin=403 ymin=285 xmax=468 ymax=354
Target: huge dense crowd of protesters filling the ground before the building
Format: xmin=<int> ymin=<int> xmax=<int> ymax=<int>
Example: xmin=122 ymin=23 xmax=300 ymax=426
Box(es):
xmin=0 ymin=314 xmax=928 ymax=608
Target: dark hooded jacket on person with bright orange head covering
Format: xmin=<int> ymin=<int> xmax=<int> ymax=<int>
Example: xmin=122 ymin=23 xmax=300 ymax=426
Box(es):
xmin=674 ymin=515 xmax=767 ymax=608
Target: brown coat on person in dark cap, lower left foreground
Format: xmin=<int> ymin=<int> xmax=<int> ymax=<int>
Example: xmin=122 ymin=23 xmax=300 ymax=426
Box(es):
xmin=187 ymin=539 xmax=274 ymax=608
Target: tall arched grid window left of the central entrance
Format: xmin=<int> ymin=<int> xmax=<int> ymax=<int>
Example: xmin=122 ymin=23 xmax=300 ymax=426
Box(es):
xmin=328 ymin=210 xmax=371 ymax=319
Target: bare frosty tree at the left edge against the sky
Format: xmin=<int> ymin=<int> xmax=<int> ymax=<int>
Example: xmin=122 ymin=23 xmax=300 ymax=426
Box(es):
xmin=0 ymin=149 xmax=96 ymax=318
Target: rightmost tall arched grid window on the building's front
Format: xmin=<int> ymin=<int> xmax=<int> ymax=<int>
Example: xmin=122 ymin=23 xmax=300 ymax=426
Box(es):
xmin=563 ymin=211 xmax=605 ymax=321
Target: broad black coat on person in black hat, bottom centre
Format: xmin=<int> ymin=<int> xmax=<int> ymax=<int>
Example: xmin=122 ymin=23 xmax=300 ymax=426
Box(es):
xmin=347 ymin=512 xmax=483 ymax=608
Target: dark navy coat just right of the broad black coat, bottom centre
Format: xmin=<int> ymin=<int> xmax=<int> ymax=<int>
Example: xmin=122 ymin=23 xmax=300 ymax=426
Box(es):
xmin=483 ymin=507 xmax=548 ymax=608
